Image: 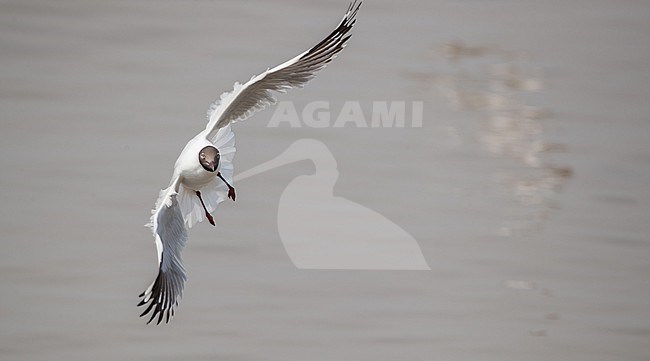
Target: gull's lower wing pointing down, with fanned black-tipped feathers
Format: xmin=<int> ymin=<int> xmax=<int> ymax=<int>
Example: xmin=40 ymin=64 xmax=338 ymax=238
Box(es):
xmin=138 ymin=180 xmax=187 ymax=324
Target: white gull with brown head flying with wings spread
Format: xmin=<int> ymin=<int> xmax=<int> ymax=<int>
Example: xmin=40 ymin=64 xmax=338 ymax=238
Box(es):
xmin=138 ymin=0 xmax=361 ymax=324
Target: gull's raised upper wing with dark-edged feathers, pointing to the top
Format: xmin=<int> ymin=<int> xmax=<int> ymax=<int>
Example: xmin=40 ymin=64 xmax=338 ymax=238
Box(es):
xmin=204 ymin=0 xmax=361 ymax=139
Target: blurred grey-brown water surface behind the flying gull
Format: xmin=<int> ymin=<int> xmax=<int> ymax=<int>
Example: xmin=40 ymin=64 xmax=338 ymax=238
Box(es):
xmin=0 ymin=0 xmax=650 ymax=361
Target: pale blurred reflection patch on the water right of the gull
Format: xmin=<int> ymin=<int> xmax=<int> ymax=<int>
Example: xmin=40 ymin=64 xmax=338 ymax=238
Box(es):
xmin=434 ymin=41 xmax=573 ymax=237
